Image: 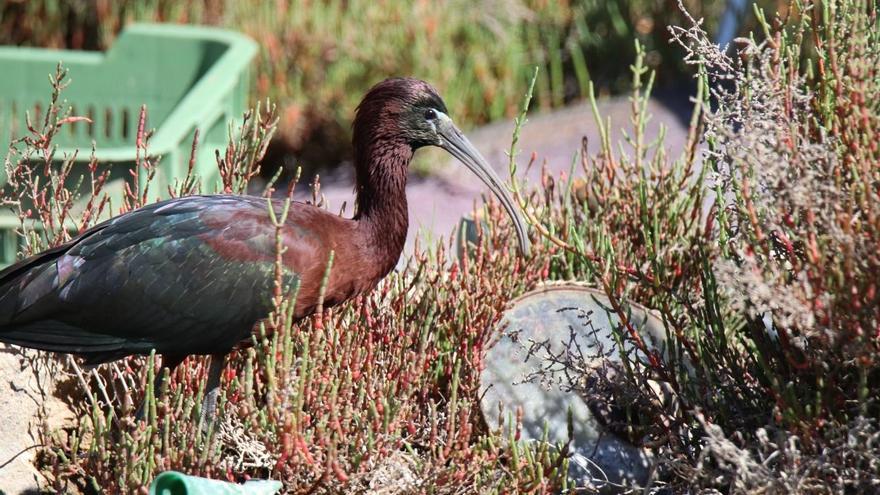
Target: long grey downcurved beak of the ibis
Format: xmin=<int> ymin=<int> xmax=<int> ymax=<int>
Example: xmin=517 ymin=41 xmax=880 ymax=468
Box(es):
xmin=437 ymin=115 xmax=530 ymax=256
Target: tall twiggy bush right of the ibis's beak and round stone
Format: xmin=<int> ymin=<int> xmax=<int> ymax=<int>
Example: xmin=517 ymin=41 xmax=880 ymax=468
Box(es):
xmin=520 ymin=1 xmax=880 ymax=493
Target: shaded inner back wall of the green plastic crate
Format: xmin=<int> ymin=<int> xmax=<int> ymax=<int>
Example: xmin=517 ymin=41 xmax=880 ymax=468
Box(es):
xmin=0 ymin=30 xmax=229 ymax=151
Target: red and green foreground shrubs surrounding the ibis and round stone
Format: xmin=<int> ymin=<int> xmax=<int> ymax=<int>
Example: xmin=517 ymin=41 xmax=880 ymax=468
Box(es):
xmin=7 ymin=1 xmax=880 ymax=493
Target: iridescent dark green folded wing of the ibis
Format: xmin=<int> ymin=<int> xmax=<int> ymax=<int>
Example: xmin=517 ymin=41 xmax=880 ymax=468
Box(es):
xmin=0 ymin=196 xmax=324 ymax=360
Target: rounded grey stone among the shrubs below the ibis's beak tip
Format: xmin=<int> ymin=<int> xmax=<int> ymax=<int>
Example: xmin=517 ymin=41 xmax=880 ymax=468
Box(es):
xmin=481 ymin=284 xmax=665 ymax=493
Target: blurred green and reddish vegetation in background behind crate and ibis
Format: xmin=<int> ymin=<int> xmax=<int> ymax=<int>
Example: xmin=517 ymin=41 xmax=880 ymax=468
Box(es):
xmin=0 ymin=0 xmax=768 ymax=177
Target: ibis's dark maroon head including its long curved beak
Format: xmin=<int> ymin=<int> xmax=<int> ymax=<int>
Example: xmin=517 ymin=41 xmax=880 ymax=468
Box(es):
xmin=354 ymin=78 xmax=530 ymax=255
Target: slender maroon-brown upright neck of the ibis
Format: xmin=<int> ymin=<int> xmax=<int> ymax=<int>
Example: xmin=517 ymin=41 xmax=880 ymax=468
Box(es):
xmin=355 ymin=135 xmax=413 ymax=273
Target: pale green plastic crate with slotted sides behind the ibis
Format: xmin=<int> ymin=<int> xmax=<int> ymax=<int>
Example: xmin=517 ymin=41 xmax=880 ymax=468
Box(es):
xmin=0 ymin=24 xmax=257 ymax=265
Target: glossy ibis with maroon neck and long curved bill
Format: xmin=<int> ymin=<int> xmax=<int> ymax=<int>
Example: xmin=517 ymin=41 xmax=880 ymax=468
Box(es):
xmin=0 ymin=78 xmax=529 ymax=422
